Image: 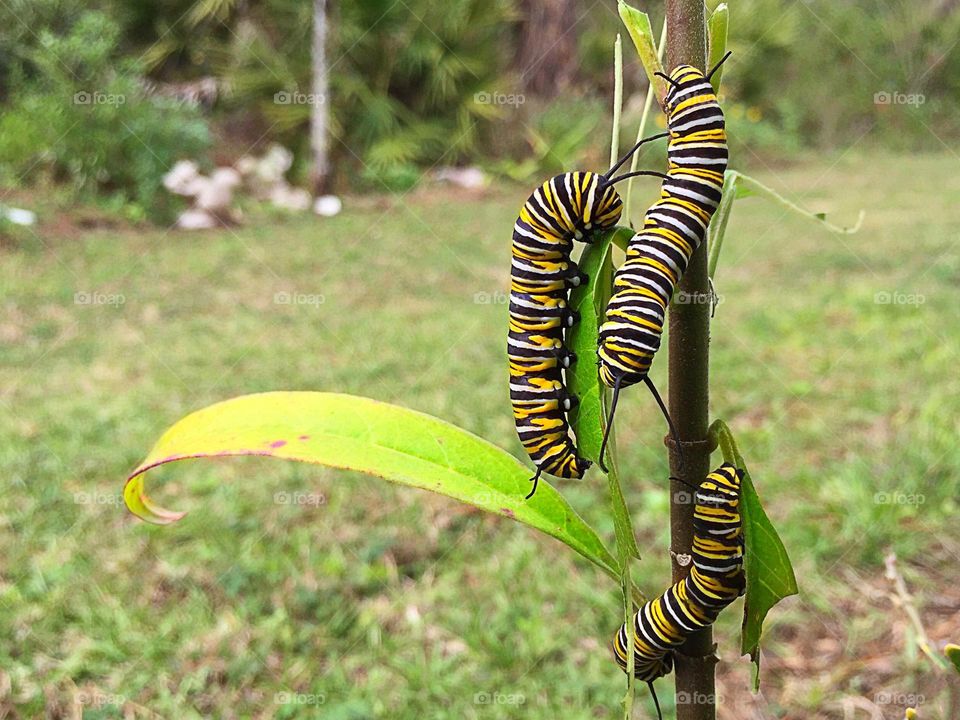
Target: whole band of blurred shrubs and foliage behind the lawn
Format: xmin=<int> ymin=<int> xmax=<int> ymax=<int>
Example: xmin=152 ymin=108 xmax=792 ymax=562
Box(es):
xmin=0 ymin=0 xmax=960 ymax=208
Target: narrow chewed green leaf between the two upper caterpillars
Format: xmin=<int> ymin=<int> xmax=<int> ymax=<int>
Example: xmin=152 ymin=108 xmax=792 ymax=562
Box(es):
xmin=567 ymin=227 xmax=640 ymax=557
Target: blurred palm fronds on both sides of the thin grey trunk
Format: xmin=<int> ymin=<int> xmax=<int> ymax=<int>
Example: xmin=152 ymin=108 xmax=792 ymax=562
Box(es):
xmin=129 ymin=0 xmax=516 ymax=190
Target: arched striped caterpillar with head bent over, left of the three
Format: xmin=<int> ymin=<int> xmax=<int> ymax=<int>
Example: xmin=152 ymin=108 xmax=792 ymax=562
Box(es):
xmin=507 ymin=133 xmax=666 ymax=498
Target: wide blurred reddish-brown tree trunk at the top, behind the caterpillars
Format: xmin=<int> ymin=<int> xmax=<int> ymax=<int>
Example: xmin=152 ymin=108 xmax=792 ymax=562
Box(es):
xmin=516 ymin=0 xmax=577 ymax=99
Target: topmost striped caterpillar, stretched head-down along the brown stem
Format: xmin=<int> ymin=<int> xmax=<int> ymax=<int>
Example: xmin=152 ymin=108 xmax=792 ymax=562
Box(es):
xmin=597 ymin=53 xmax=730 ymax=467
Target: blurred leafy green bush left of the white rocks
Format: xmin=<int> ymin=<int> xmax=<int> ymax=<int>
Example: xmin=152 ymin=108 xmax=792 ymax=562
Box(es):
xmin=0 ymin=2 xmax=209 ymax=221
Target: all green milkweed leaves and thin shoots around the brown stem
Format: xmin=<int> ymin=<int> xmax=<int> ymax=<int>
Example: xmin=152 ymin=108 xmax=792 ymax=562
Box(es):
xmin=123 ymin=2 xmax=924 ymax=719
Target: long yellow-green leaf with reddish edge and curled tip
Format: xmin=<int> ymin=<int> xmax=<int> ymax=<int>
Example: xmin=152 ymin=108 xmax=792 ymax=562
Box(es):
xmin=124 ymin=392 xmax=620 ymax=582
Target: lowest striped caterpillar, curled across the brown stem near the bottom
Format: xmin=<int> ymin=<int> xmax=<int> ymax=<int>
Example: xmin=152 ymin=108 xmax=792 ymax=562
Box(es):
xmin=613 ymin=463 xmax=745 ymax=714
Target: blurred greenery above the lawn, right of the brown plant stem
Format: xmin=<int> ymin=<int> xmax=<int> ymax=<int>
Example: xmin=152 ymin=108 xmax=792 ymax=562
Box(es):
xmin=708 ymin=0 xmax=960 ymax=151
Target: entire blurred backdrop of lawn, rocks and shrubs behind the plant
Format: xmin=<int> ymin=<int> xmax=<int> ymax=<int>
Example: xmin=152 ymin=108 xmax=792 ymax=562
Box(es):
xmin=0 ymin=0 xmax=960 ymax=720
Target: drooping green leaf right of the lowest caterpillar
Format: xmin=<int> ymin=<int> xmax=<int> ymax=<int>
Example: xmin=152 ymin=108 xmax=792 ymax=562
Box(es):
xmin=709 ymin=420 xmax=799 ymax=692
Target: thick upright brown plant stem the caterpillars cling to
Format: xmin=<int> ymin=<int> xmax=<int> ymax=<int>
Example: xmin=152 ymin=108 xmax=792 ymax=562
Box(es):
xmin=666 ymin=0 xmax=716 ymax=720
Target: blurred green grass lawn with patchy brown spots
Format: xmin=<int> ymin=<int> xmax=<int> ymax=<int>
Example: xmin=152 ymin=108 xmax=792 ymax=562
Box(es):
xmin=0 ymin=157 xmax=960 ymax=720
